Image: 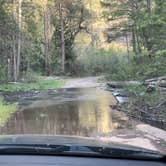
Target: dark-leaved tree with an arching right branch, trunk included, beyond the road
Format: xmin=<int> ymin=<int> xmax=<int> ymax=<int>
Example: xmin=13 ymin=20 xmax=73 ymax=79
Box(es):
xmin=52 ymin=0 xmax=87 ymax=72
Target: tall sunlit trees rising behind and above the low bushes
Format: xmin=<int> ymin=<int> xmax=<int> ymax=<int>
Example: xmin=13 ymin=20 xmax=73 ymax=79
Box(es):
xmin=0 ymin=0 xmax=166 ymax=81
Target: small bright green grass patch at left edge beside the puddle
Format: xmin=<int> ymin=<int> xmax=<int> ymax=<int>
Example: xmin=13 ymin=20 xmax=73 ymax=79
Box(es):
xmin=0 ymin=99 xmax=16 ymax=125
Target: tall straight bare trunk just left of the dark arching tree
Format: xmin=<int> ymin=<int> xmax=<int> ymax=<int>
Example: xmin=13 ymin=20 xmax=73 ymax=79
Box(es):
xmin=43 ymin=0 xmax=50 ymax=76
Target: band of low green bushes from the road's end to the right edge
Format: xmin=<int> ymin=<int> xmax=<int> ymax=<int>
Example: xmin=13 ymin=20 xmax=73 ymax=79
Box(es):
xmin=73 ymin=44 xmax=166 ymax=81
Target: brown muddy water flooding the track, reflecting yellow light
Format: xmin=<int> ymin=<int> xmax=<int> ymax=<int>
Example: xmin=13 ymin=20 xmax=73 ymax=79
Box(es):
xmin=0 ymin=88 xmax=126 ymax=137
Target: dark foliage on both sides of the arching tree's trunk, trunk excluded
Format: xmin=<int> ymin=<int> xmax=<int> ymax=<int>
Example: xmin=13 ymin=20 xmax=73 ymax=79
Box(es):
xmin=51 ymin=0 xmax=87 ymax=71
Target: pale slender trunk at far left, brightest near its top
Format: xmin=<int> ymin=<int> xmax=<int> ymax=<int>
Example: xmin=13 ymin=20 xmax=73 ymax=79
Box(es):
xmin=16 ymin=0 xmax=22 ymax=80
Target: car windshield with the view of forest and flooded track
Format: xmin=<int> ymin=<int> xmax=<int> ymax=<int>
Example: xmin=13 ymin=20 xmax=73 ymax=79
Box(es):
xmin=0 ymin=0 xmax=166 ymax=155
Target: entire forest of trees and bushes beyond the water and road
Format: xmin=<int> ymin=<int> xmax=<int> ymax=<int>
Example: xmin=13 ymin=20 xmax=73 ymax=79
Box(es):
xmin=0 ymin=0 xmax=166 ymax=83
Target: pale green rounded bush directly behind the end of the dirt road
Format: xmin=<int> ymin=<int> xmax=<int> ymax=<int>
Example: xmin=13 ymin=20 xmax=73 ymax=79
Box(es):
xmin=73 ymin=46 xmax=126 ymax=75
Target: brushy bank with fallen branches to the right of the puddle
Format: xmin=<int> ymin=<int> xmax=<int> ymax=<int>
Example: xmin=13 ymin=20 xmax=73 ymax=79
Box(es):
xmin=119 ymin=86 xmax=166 ymax=130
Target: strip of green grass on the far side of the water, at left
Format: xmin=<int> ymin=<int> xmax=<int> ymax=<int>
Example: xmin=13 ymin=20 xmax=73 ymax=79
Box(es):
xmin=0 ymin=79 xmax=65 ymax=91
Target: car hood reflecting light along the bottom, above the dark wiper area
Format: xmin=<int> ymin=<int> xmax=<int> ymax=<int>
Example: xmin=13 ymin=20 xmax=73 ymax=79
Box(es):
xmin=0 ymin=135 xmax=158 ymax=150
